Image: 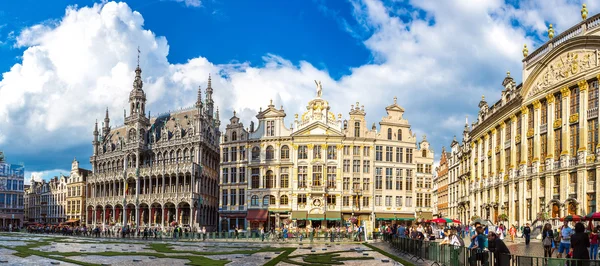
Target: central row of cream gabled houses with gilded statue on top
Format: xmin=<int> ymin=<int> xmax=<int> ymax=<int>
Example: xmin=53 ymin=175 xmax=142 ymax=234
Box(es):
xmin=219 ymin=82 xmax=433 ymax=233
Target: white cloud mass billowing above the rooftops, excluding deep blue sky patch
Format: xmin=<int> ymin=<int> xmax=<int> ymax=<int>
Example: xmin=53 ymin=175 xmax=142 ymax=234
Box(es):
xmin=0 ymin=0 xmax=594 ymax=172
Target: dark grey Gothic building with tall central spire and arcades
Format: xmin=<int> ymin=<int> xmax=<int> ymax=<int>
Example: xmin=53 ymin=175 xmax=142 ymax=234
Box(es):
xmin=86 ymin=61 xmax=220 ymax=230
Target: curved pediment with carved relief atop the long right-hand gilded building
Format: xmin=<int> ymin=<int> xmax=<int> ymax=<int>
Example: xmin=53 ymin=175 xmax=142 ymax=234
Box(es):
xmin=527 ymin=49 xmax=598 ymax=98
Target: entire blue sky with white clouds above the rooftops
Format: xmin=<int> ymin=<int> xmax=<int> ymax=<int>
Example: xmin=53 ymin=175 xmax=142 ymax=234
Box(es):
xmin=0 ymin=0 xmax=600 ymax=183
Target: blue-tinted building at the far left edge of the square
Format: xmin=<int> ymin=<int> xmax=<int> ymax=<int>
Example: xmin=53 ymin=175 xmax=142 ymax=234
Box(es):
xmin=0 ymin=151 xmax=25 ymax=228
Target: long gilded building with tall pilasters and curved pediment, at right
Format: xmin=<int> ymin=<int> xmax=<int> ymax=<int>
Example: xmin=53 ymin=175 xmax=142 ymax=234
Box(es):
xmin=457 ymin=12 xmax=600 ymax=225
